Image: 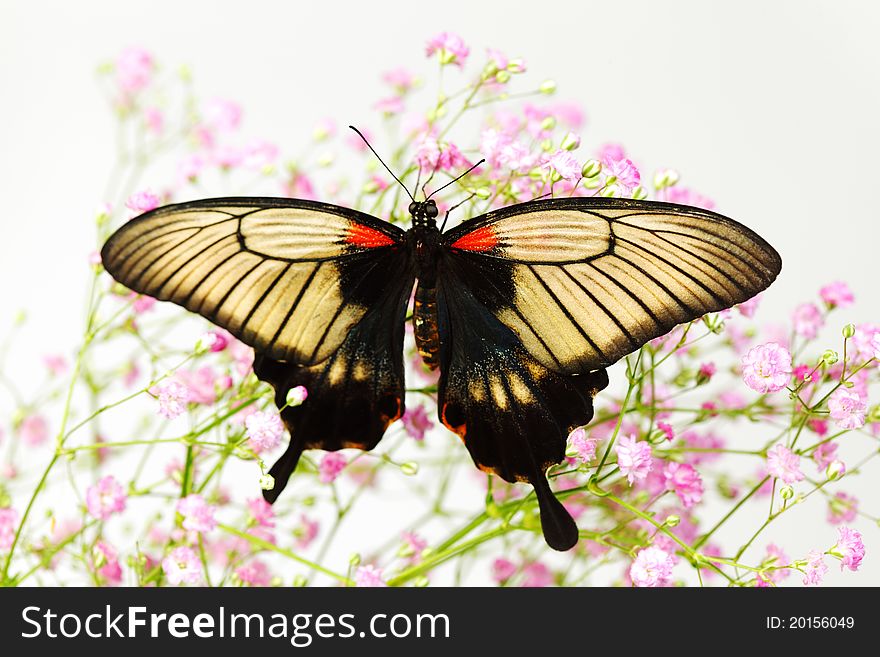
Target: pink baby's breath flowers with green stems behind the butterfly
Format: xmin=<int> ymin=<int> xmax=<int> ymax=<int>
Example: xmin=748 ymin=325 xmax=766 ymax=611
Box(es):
xmin=0 ymin=33 xmax=880 ymax=586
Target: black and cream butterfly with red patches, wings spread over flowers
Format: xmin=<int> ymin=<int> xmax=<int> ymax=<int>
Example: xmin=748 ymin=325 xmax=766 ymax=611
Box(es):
xmin=101 ymin=160 xmax=782 ymax=550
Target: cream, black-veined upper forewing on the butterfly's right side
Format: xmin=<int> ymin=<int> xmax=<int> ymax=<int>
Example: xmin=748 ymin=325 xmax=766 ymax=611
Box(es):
xmin=443 ymin=198 xmax=781 ymax=374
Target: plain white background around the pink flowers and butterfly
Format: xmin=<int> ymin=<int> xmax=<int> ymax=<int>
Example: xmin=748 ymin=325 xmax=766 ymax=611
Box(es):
xmin=0 ymin=0 xmax=880 ymax=584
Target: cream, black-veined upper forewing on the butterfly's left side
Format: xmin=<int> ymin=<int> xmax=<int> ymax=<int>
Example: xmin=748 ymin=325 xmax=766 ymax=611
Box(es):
xmin=101 ymin=198 xmax=404 ymax=365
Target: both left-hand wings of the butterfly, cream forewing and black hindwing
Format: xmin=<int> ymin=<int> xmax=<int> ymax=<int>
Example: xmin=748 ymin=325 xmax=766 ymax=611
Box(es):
xmin=102 ymin=198 xmax=414 ymax=502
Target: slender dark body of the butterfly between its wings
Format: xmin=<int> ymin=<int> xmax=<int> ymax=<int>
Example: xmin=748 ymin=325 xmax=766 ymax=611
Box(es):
xmin=407 ymin=199 xmax=440 ymax=370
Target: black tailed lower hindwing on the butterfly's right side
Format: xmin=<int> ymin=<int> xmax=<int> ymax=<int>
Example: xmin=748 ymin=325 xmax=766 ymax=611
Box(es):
xmin=437 ymin=259 xmax=608 ymax=550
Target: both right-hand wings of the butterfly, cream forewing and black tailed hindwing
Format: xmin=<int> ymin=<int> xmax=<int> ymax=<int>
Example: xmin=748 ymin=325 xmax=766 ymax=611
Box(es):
xmin=437 ymin=198 xmax=781 ymax=550
